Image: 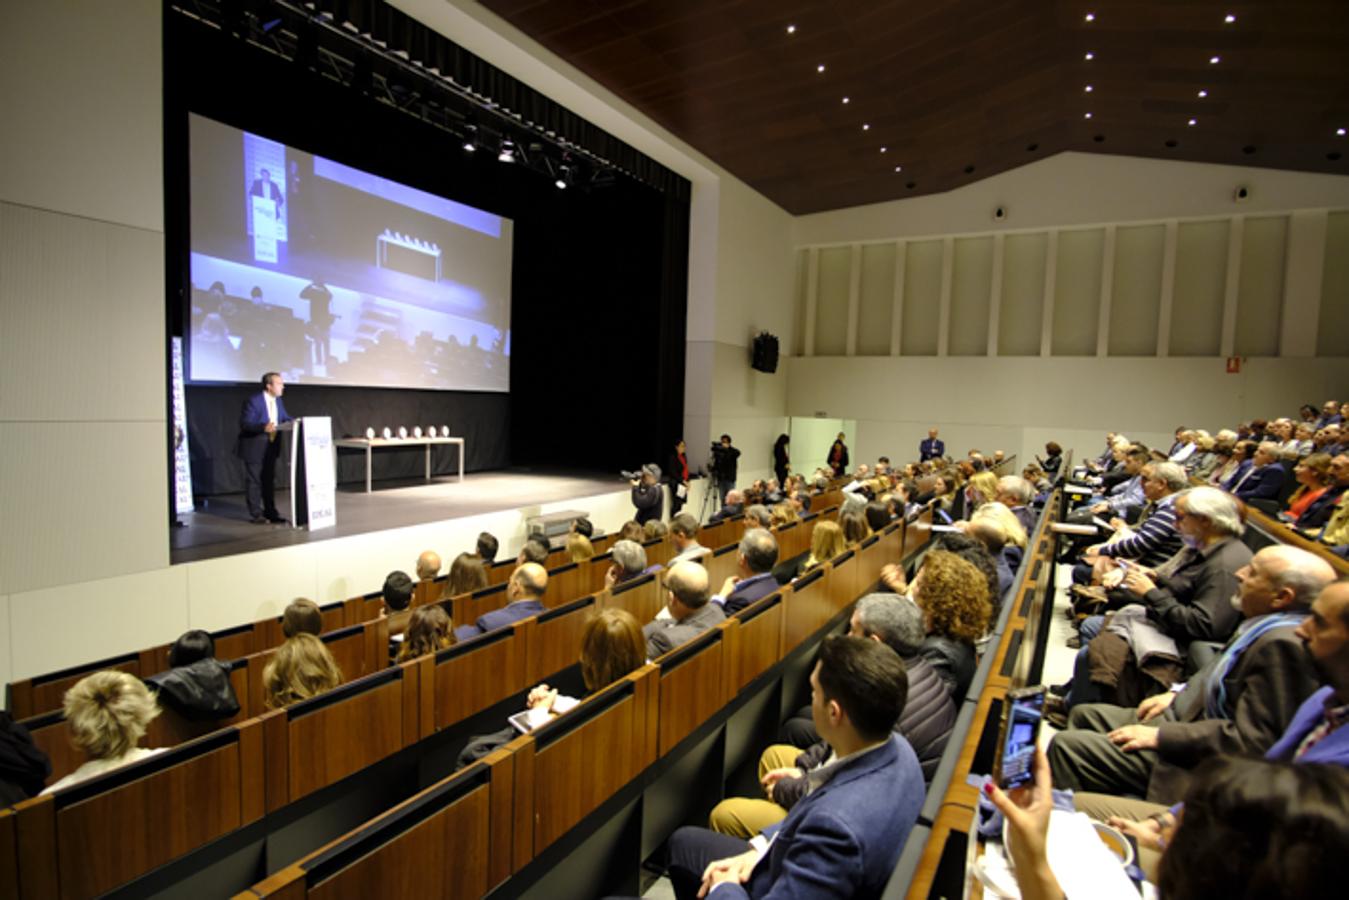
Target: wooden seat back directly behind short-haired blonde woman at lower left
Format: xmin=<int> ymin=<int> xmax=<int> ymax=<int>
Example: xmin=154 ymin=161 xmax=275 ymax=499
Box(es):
xmin=13 ymin=719 xmax=264 ymax=900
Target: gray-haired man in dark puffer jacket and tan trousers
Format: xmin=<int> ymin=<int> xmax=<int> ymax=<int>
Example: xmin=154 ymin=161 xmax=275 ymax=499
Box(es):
xmin=708 ymin=594 xmax=956 ymax=839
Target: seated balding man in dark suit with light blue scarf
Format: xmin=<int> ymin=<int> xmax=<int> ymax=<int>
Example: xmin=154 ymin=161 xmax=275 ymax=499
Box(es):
xmin=1050 ymin=544 xmax=1336 ymax=803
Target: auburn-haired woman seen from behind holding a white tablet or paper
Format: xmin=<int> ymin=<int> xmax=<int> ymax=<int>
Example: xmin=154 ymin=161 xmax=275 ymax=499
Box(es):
xmin=459 ymin=609 xmax=646 ymax=768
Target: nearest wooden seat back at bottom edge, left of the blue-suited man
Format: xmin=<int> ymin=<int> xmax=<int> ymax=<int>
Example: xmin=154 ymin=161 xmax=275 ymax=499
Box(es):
xmin=247 ymin=749 xmax=519 ymax=900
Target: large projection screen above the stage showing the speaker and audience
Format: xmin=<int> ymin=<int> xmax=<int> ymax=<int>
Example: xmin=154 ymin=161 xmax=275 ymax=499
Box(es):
xmin=188 ymin=115 xmax=513 ymax=391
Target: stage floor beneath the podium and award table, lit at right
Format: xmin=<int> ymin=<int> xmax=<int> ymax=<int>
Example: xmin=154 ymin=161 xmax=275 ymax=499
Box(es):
xmin=169 ymin=468 xmax=627 ymax=564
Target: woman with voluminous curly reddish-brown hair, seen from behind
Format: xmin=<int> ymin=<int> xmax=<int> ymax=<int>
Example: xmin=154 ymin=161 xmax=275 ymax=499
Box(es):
xmin=913 ymin=551 xmax=993 ymax=703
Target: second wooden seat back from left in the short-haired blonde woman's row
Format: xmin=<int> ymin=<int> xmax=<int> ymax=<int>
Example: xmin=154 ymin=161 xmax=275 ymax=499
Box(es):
xmin=262 ymin=665 xmax=420 ymax=812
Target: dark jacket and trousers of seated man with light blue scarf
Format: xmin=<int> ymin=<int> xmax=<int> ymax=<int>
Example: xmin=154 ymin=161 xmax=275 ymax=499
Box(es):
xmin=1050 ymin=627 xmax=1317 ymax=803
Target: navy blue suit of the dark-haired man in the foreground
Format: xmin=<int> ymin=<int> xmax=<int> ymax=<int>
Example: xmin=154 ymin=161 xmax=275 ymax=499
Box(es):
xmin=669 ymin=735 xmax=924 ymax=900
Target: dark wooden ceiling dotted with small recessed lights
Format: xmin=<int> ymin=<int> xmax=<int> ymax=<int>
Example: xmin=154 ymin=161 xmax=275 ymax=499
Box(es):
xmin=484 ymin=0 xmax=1349 ymax=213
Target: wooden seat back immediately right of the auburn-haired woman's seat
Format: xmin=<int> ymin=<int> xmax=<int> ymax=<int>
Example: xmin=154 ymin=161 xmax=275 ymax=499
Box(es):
xmin=653 ymin=619 xmax=739 ymax=756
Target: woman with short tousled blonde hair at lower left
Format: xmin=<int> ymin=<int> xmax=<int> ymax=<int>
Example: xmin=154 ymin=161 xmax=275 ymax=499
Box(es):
xmin=43 ymin=672 xmax=159 ymax=793
